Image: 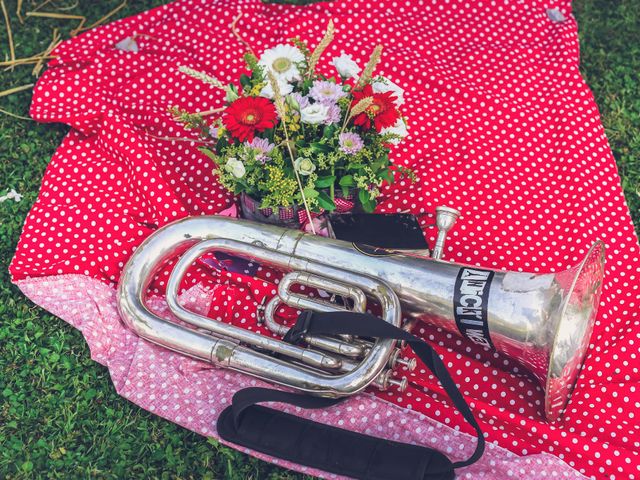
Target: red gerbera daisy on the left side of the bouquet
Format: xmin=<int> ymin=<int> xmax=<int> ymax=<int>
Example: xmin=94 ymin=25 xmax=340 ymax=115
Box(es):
xmin=222 ymin=97 xmax=277 ymax=142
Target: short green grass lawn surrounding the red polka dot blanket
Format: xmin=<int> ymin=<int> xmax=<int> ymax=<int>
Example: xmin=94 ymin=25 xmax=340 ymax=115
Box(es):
xmin=0 ymin=0 xmax=640 ymax=479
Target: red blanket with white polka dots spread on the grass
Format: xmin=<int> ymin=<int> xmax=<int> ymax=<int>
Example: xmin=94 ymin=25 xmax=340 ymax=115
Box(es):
xmin=11 ymin=0 xmax=640 ymax=479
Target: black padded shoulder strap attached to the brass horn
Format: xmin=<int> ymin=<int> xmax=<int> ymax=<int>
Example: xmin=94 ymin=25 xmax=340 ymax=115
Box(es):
xmin=217 ymin=311 xmax=485 ymax=480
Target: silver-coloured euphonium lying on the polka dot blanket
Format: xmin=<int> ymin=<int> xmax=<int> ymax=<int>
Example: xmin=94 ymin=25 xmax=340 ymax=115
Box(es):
xmin=118 ymin=207 xmax=604 ymax=421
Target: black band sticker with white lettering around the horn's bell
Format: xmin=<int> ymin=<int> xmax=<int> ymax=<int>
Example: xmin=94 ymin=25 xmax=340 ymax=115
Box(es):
xmin=453 ymin=268 xmax=494 ymax=348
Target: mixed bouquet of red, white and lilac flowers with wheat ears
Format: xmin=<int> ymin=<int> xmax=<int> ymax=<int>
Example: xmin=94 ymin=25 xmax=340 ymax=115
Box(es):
xmin=172 ymin=22 xmax=413 ymax=232
